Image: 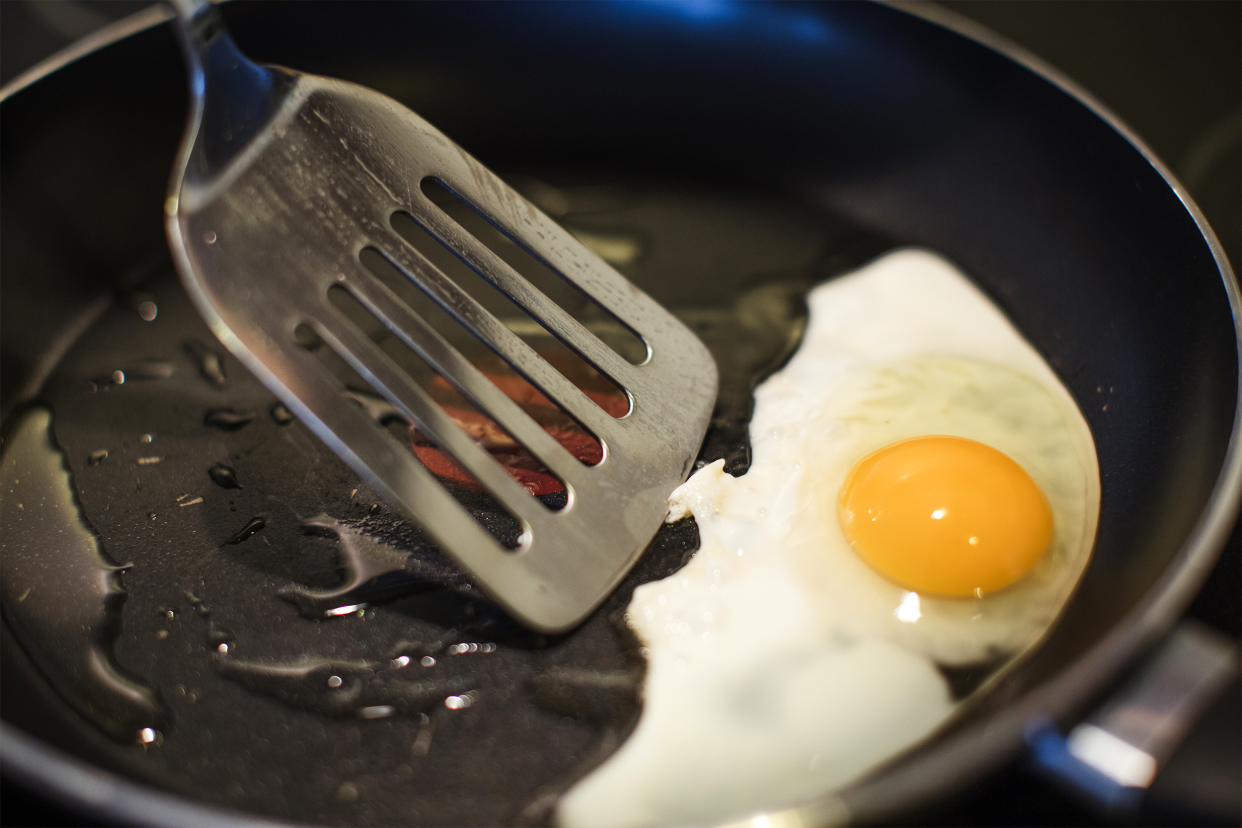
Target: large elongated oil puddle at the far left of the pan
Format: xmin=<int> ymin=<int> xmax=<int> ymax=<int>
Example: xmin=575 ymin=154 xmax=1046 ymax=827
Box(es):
xmin=0 ymin=408 xmax=168 ymax=742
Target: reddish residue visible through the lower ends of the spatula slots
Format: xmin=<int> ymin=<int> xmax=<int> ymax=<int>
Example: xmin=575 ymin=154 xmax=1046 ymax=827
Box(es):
xmin=410 ymin=354 xmax=630 ymax=495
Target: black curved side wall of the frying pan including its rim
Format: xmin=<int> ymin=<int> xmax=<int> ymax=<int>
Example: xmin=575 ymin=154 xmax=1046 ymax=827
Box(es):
xmin=0 ymin=0 xmax=1242 ymax=826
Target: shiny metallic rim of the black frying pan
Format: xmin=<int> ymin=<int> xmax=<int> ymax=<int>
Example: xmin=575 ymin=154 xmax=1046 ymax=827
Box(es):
xmin=0 ymin=0 xmax=1242 ymax=828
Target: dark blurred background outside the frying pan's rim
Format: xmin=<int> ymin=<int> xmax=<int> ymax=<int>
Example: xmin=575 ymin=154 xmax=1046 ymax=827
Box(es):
xmin=0 ymin=0 xmax=1242 ymax=828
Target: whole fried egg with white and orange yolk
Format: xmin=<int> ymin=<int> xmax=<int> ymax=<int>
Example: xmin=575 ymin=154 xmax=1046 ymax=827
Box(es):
xmin=558 ymin=250 xmax=1099 ymax=828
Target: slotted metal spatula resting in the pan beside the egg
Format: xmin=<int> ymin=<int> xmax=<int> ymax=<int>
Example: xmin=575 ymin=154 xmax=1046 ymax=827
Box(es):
xmin=165 ymin=0 xmax=717 ymax=632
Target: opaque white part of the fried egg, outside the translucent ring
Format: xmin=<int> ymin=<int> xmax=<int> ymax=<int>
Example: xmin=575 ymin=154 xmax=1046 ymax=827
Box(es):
xmin=558 ymin=250 xmax=1099 ymax=828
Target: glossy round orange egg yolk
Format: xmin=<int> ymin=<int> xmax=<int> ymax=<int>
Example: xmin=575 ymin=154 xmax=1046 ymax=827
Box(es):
xmin=837 ymin=436 xmax=1052 ymax=597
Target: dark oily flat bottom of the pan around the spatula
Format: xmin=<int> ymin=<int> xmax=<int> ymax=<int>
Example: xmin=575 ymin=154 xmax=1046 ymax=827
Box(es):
xmin=0 ymin=176 xmax=1078 ymax=826
